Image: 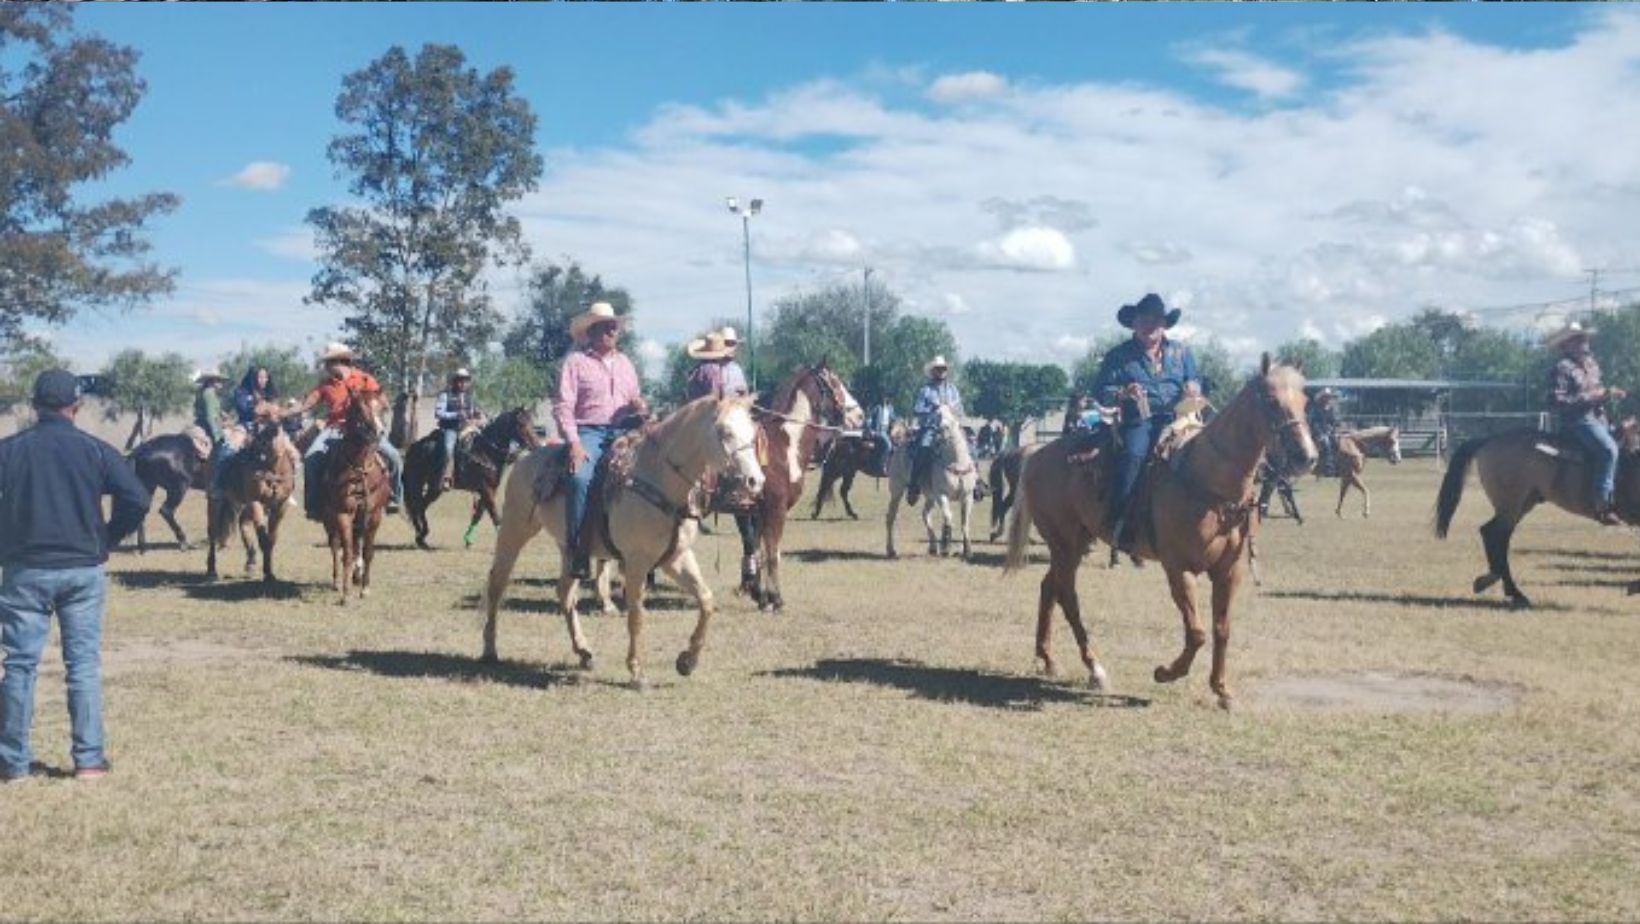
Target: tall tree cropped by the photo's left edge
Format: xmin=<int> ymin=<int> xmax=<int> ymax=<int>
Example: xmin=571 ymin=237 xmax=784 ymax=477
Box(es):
xmin=0 ymin=3 xmax=179 ymax=351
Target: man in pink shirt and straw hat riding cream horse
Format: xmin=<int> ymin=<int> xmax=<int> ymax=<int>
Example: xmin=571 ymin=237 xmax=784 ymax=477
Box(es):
xmin=553 ymin=302 xmax=649 ymax=581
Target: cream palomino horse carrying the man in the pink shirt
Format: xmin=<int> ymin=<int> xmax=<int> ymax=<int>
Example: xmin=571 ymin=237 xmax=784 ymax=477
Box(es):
xmin=484 ymin=396 xmax=763 ymax=688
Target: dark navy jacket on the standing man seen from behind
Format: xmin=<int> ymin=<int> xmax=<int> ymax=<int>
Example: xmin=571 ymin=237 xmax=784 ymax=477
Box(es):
xmin=0 ymin=414 xmax=149 ymax=569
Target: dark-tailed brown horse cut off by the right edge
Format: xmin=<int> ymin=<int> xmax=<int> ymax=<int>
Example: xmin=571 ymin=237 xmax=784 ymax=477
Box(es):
xmin=1435 ymin=417 xmax=1640 ymax=607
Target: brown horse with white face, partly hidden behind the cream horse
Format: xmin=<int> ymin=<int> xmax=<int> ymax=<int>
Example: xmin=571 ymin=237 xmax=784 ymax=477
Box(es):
xmin=736 ymin=363 xmax=866 ymax=611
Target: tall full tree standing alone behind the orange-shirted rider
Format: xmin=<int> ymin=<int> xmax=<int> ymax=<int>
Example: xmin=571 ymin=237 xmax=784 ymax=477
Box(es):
xmin=308 ymin=44 xmax=541 ymax=438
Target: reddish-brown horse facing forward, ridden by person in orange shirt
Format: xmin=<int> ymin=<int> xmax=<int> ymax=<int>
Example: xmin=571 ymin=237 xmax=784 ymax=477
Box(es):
xmin=320 ymin=397 xmax=392 ymax=606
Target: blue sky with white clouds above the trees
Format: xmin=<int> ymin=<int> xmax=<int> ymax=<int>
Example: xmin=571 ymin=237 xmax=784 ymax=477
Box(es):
xmin=59 ymin=3 xmax=1640 ymax=372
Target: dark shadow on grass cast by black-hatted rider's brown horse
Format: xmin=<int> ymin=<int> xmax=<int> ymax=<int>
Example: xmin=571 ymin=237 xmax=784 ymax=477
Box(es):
xmin=758 ymin=658 xmax=1150 ymax=711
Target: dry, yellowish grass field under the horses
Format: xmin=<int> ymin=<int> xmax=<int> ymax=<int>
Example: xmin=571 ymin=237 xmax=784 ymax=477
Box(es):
xmin=0 ymin=461 xmax=1640 ymax=921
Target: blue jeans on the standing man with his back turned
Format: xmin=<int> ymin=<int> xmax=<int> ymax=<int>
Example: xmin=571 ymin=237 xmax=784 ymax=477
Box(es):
xmin=0 ymin=566 xmax=108 ymax=776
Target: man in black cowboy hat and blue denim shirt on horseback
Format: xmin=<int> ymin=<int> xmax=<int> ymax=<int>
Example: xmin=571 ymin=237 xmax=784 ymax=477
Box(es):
xmin=1097 ymin=292 xmax=1202 ymax=565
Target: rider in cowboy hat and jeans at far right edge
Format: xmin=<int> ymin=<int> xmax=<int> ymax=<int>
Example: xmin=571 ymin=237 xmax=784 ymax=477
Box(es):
xmin=1545 ymin=322 xmax=1629 ymax=527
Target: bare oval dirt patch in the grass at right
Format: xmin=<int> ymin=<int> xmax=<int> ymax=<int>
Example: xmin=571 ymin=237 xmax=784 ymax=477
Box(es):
xmin=1256 ymin=671 xmax=1520 ymax=712
